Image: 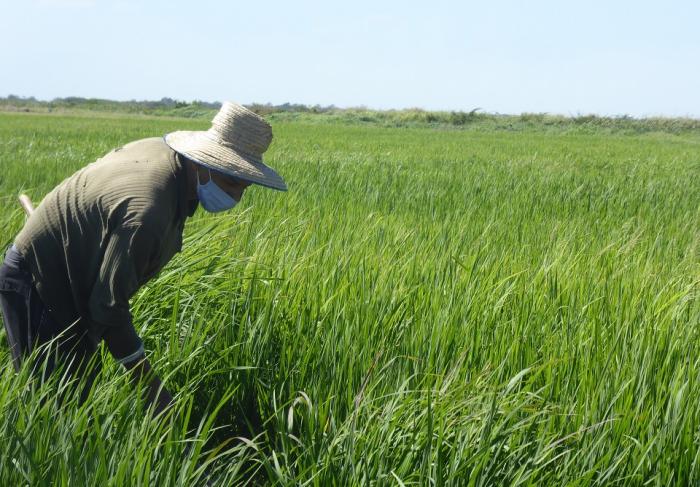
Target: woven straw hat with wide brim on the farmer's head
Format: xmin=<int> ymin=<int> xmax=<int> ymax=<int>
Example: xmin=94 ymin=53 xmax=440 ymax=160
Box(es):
xmin=164 ymin=101 xmax=287 ymax=191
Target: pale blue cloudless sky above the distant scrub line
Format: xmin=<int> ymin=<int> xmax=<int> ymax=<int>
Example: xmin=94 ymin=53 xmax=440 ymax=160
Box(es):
xmin=0 ymin=0 xmax=700 ymax=118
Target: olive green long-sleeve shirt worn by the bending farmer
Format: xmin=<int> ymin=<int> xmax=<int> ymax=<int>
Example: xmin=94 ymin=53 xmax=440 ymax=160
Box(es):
xmin=15 ymin=138 xmax=197 ymax=361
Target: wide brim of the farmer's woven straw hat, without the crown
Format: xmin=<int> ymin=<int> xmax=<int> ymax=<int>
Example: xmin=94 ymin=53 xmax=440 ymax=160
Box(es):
xmin=163 ymin=130 xmax=287 ymax=191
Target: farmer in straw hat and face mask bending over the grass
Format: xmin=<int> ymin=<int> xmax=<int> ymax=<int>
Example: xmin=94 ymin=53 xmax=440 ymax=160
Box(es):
xmin=0 ymin=102 xmax=287 ymax=411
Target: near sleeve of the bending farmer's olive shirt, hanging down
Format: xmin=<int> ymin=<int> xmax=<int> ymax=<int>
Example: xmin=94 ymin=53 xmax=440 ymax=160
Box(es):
xmin=89 ymin=225 xmax=159 ymax=364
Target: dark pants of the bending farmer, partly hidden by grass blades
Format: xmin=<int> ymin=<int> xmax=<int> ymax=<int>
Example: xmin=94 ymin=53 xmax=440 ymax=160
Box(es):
xmin=0 ymin=246 xmax=100 ymax=398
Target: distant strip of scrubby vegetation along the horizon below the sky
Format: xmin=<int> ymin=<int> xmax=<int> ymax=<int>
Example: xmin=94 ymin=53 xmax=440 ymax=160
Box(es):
xmin=5 ymin=95 xmax=700 ymax=135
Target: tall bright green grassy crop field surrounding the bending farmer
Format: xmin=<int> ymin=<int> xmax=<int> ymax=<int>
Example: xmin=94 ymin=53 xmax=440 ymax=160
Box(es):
xmin=0 ymin=113 xmax=700 ymax=486
